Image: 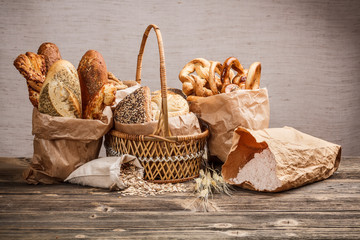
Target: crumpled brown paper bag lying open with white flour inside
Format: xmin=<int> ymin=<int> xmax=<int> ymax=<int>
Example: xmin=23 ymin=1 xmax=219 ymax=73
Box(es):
xmin=222 ymin=127 xmax=341 ymax=192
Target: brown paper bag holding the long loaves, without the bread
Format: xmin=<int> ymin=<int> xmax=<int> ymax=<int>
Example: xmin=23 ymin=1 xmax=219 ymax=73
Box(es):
xmin=23 ymin=108 xmax=113 ymax=184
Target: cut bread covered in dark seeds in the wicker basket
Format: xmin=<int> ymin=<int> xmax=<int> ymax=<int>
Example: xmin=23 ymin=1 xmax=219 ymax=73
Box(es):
xmin=114 ymin=87 xmax=152 ymax=124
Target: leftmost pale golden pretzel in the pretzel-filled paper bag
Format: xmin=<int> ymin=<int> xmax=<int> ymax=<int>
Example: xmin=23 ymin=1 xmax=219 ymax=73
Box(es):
xmin=179 ymin=58 xmax=210 ymax=96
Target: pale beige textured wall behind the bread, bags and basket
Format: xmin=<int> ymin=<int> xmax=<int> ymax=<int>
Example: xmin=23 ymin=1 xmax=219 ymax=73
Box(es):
xmin=0 ymin=0 xmax=360 ymax=157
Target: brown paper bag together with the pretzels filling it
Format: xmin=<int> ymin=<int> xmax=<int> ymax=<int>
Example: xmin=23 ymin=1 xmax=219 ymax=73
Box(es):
xmin=179 ymin=57 xmax=270 ymax=162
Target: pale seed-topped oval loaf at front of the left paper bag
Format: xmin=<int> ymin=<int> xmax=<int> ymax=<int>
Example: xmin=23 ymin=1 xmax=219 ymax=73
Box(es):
xmin=39 ymin=60 xmax=81 ymax=118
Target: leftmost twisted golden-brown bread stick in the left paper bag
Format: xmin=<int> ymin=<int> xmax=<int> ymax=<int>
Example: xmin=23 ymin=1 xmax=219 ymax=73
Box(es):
xmin=14 ymin=52 xmax=46 ymax=108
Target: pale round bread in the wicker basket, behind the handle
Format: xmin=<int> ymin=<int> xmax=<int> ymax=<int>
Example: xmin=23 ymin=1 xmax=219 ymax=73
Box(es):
xmin=151 ymin=90 xmax=189 ymax=120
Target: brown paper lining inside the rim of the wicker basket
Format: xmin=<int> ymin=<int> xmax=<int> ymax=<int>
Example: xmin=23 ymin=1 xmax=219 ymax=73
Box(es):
xmin=115 ymin=113 xmax=201 ymax=136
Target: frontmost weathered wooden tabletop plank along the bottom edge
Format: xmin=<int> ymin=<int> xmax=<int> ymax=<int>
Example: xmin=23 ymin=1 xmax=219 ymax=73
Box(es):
xmin=2 ymin=211 xmax=360 ymax=239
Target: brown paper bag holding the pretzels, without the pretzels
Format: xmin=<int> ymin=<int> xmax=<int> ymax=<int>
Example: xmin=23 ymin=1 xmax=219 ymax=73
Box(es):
xmin=190 ymin=88 xmax=270 ymax=162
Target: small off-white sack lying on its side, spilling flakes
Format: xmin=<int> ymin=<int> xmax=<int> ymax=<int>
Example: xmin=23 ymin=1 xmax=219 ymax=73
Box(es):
xmin=65 ymin=154 xmax=144 ymax=190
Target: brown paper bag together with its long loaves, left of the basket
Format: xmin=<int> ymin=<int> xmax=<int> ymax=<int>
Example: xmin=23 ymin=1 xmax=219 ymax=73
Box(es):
xmin=14 ymin=43 xmax=126 ymax=184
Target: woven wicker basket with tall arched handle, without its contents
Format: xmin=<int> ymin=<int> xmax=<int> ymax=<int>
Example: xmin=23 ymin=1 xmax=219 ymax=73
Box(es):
xmin=105 ymin=25 xmax=209 ymax=183
